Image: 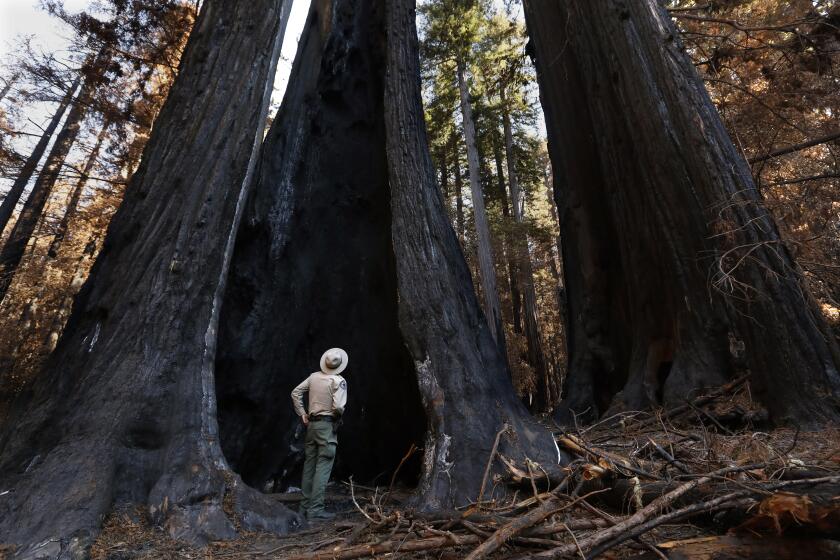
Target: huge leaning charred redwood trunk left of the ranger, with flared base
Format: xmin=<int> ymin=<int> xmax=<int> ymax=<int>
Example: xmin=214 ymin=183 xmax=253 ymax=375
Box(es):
xmin=0 ymin=0 xmax=297 ymax=557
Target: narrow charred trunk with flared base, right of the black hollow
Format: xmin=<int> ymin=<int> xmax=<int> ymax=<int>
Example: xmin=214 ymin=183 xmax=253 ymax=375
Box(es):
xmin=385 ymin=0 xmax=563 ymax=509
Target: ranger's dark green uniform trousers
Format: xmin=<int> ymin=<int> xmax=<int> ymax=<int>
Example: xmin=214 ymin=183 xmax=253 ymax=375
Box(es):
xmin=300 ymin=420 xmax=338 ymax=515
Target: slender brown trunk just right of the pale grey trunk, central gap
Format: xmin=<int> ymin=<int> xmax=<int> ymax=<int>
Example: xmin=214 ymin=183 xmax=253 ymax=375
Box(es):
xmin=500 ymin=87 xmax=559 ymax=411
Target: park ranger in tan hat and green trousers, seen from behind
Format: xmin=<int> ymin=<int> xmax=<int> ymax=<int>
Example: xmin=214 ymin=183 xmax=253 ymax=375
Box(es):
xmin=292 ymin=348 xmax=347 ymax=520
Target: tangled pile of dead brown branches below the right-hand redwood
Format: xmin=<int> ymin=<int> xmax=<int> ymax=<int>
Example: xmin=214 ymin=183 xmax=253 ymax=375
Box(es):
xmin=282 ymin=379 xmax=840 ymax=560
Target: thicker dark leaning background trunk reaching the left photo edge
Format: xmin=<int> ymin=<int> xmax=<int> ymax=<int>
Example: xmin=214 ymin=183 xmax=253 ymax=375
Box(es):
xmin=0 ymin=68 xmax=102 ymax=302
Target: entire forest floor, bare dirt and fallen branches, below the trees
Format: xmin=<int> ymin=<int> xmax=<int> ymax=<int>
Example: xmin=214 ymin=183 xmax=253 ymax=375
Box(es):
xmin=91 ymin=382 xmax=840 ymax=560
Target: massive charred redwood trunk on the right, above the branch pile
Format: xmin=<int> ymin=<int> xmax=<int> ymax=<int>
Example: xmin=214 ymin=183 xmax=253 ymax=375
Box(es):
xmin=525 ymin=0 xmax=840 ymax=424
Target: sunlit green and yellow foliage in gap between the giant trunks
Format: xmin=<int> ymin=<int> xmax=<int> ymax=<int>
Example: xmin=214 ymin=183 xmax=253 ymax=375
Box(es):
xmin=419 ymin=0 xmax=564 ymax=396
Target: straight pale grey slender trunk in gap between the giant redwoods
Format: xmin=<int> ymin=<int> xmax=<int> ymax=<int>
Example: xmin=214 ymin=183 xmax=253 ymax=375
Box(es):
xmin=457 ymin=60 xmax=505 ymax=349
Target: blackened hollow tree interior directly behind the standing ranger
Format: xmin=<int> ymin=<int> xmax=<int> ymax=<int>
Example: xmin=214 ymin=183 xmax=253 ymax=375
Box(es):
xmin=217 ymin=0 xmax=425 ymax=489
